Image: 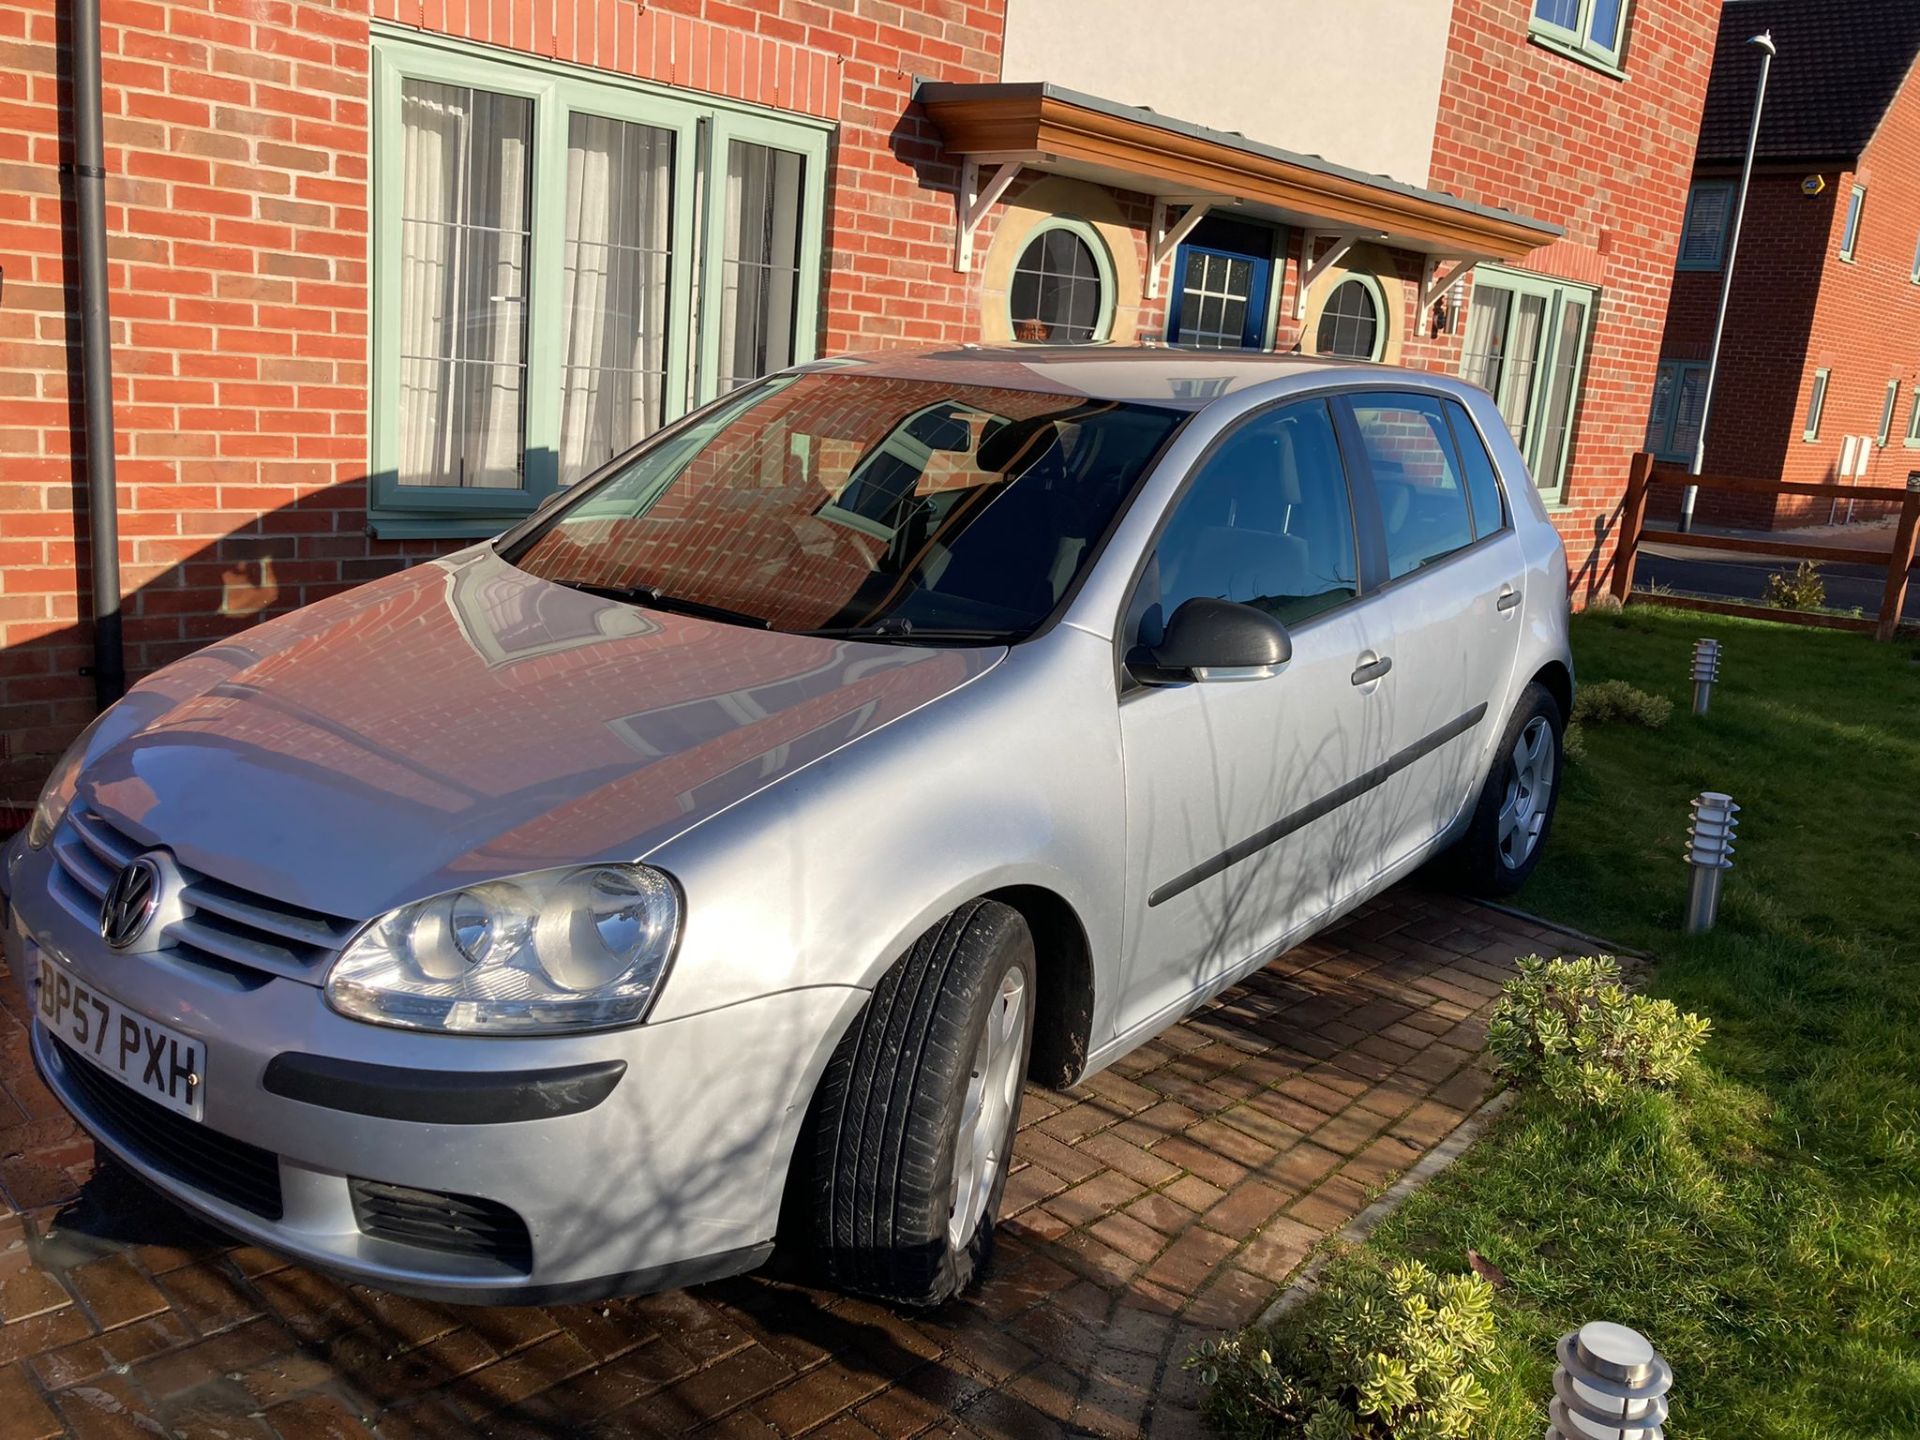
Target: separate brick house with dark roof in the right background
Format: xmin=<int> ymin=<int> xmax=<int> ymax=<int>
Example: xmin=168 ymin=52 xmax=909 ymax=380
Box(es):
xmin=1647 ymin=0 xmax=1920 ymax=528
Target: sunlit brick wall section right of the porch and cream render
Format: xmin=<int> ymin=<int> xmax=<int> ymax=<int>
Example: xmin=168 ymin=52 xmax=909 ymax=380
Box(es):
xmin=1430 ymin=0 xmax=1720 ymax=603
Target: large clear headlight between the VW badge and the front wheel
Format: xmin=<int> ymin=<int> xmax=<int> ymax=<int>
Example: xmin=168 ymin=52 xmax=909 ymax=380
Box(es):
xmin=326 ymin=866 xmax=680 ymax=1035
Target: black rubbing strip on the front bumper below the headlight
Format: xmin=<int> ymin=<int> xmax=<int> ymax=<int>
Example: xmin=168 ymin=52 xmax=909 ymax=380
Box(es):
xmin=261 ymin=1052 xmax=626 ymax=1125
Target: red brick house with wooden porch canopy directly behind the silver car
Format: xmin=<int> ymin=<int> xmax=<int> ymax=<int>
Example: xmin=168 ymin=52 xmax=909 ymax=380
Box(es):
xmin=0 ymin=0 xmax=1712 ymax=804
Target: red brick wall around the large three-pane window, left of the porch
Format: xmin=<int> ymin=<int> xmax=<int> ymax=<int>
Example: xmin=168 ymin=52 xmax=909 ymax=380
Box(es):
xmin=0 ymin=0 xmax=1002 ymax=804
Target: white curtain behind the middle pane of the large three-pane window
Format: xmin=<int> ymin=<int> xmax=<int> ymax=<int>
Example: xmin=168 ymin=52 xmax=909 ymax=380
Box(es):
xmin=561 ymin=113 xmax=674 ymax=486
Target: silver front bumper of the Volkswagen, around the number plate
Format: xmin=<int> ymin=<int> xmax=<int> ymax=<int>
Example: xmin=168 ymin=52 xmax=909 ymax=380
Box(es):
xmin=4 ymin=841 xmax=866 ymax=1304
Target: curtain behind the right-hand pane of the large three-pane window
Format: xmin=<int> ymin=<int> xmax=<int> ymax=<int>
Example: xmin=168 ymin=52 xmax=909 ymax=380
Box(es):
xmin=720 ymin=140 xmax=806 ymax=392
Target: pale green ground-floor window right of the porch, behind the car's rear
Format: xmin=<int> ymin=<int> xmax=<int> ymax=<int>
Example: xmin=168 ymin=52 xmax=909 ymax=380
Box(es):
xmin=1459 ymin=265 xmax=1599 ymax=503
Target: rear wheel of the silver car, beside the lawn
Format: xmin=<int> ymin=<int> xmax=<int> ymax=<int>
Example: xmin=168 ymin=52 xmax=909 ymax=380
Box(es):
xmin=1453 ymin=684 xmax=1567 ymax=897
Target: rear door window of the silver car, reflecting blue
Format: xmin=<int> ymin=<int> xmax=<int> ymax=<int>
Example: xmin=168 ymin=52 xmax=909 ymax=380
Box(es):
xmin=1352 ymin=394 xmax=1473 ymax=580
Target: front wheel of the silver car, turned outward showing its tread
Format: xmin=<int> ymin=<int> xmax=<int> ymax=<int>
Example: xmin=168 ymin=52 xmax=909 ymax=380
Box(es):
xmin=810 ymin=900 xmax=1035 ymax=1306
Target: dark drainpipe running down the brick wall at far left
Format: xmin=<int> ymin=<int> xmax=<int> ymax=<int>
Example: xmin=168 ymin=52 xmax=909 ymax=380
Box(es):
xmin=73 ymin=0 xmax=127 ymax=710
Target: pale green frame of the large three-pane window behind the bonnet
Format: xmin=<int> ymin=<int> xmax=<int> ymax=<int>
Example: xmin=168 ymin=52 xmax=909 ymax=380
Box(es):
xmin=367 ymin=25 xmax=831 ymax=538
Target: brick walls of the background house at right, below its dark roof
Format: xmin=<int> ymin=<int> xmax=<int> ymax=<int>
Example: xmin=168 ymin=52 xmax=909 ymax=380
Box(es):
xmin=1661 ymin=54 xmax=1920 ymax=526
